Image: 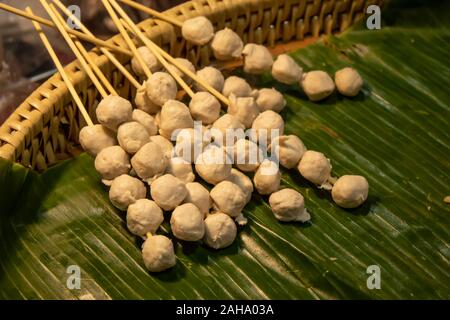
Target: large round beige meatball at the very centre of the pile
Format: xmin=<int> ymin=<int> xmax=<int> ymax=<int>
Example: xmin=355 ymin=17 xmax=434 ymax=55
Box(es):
xmin=195 ymin=146 xmax=232 ymax=184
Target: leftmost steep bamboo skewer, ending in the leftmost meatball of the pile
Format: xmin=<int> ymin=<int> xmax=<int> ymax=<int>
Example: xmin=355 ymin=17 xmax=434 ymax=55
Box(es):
xmin=25 ymin=7 xmax=94 ymax=126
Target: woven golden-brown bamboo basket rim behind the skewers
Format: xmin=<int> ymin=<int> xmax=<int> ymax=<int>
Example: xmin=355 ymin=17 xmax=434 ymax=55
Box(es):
xmin=0 ymin=0 xmax=382 ymax=171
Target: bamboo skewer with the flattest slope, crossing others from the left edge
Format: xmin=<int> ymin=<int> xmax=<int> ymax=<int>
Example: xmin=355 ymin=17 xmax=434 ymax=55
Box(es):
xmin=0 ymin=3 xmax=133 ymax=56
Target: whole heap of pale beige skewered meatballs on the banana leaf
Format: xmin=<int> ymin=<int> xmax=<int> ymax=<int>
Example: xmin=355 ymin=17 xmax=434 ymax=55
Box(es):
xmin=79 ymin=17 xmax=369 ymax=272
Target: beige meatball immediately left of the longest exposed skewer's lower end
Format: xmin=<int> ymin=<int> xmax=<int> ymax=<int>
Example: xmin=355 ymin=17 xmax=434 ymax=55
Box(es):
xmin=189 ymin=91 xmax=221 ymax=125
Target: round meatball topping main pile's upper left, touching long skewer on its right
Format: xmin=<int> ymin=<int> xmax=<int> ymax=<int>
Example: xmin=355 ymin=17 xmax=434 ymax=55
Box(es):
xmin=145 ymin=72 xmax=178 ymax=106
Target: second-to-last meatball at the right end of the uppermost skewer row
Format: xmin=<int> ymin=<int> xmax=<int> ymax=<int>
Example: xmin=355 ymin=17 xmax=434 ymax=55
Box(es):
xmin=301 ymin=70 xmax=334 ymax=101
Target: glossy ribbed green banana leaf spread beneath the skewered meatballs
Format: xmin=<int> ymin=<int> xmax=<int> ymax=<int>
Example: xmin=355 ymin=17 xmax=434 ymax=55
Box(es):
xmin=0 ymin=1 xmax=450 ymax=299
